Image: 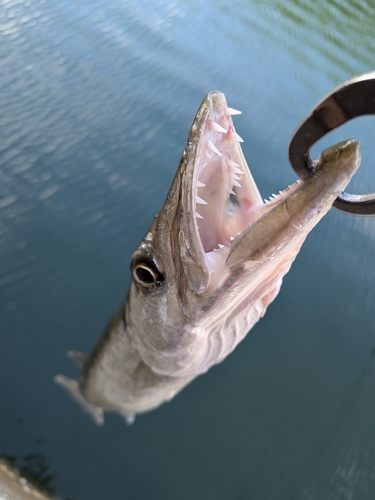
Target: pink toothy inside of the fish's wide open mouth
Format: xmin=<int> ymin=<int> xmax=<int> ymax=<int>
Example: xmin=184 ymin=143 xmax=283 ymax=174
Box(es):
xmin=192 ymin=91 xmax=297 ymax=263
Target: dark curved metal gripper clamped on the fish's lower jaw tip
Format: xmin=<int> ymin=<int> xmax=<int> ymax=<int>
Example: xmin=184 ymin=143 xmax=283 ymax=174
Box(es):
xmin=288 ymin=71 xmax=375 ymax=215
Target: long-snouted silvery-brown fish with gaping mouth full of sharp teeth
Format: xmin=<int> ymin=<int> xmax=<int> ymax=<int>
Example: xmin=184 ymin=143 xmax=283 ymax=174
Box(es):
xmin=55 ymin=91 xmax=361 ymax=425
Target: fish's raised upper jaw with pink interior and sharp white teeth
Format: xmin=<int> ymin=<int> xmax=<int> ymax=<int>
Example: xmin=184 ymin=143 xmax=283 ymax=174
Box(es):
xmin=179 ymin=91 xmax=284 ymax=294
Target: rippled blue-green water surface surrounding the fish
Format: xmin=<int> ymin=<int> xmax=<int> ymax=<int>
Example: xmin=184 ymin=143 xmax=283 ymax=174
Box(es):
xmin=0 ymin=0 xmax=375 ymax=500
